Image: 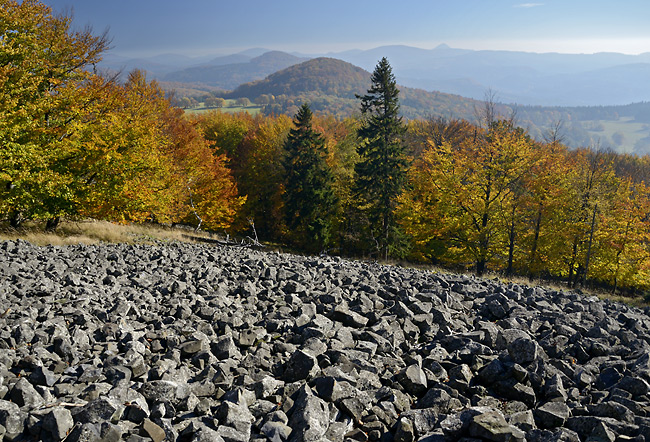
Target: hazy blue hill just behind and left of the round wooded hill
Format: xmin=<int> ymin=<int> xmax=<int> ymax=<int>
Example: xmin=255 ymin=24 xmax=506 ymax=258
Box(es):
xmin=162 ymin=51 xmax=305 ymax=89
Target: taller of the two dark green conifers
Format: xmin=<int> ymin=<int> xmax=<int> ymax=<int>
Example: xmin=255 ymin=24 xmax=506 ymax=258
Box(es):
xmin=355 ymin=57 xmax=408 ymax=259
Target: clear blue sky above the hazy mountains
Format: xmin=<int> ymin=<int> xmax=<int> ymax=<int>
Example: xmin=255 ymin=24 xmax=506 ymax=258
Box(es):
xmin=42 ymin=0 xmax=650 ymax=57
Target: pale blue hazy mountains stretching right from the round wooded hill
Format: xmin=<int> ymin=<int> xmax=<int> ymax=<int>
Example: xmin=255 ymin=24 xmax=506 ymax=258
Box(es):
xmin=330 ymin=45 xmax=650 ymax=106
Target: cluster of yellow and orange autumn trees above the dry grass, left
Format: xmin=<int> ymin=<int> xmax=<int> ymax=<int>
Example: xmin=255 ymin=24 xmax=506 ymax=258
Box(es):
xmin=0 ymin=0 xmax=243 ymax=229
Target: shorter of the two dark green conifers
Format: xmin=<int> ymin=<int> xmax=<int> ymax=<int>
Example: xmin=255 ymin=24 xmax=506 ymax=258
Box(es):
xmin=284 ymin=104 xmax=336 ymax=252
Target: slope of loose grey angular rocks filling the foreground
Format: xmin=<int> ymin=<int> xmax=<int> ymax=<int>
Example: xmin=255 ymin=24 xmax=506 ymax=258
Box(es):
xmin=0 ymin=240 xmax=650 ymax=442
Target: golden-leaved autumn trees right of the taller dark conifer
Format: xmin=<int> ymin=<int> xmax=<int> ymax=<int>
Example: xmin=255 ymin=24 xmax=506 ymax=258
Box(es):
xmin=399 ymin=120 xmax=650 ymax=290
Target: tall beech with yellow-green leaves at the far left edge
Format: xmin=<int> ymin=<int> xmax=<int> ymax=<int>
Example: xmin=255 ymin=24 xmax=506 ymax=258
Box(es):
xmin=0 ymin=0 xmax=108 ymax=226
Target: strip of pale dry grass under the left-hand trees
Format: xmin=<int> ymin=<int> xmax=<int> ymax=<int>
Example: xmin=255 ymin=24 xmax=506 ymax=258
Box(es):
xmin=0 ymin=220 xmax=216 ymax=246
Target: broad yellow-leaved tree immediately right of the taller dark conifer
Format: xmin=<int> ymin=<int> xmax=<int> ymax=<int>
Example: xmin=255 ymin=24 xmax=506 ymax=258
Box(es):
xmin=401 ymin=120 xmax=531 ymax=275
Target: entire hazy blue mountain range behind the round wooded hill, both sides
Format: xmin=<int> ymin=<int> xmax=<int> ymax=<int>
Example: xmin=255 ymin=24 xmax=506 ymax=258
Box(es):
xmin=102 ymin=45 xmax=650 ymax=106
